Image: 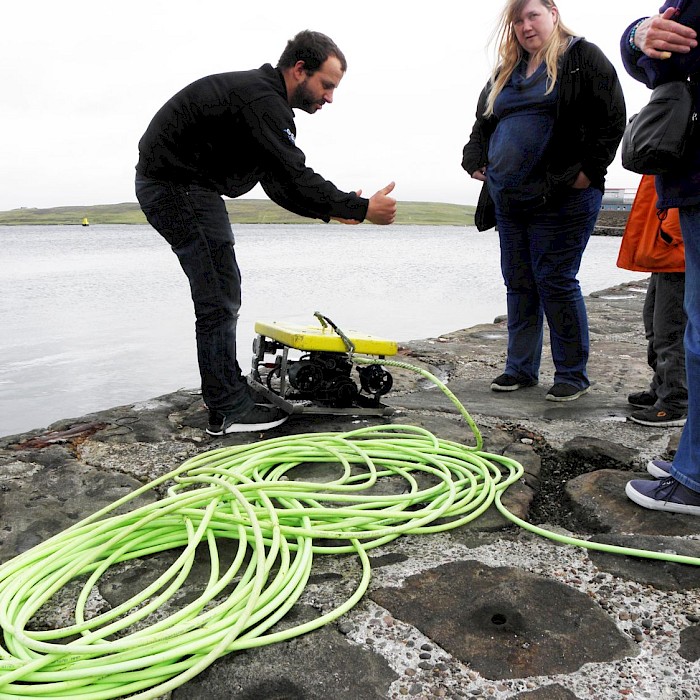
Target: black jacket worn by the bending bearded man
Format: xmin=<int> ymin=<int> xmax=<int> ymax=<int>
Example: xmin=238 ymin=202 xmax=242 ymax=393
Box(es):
xmin=136 ymin=64 xmax=368 ymax=221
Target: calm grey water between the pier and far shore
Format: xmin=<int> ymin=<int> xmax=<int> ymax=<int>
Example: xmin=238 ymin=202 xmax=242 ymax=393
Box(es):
xmin=0 ymin=225 xmax=644 ymax=435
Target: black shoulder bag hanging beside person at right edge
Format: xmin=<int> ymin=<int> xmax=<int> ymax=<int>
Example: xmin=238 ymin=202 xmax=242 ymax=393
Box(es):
xmin=622 ymin=80 xmax=698 ymax=175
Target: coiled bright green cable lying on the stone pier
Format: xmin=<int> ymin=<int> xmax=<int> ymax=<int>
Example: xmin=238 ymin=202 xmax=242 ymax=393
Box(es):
xmin=0 ymin=356 xmax=700 ymax=700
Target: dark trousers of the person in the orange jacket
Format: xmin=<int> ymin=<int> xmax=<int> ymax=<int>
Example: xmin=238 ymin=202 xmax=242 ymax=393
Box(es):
xmin=643 ymin=272 xmax=688 ymax=413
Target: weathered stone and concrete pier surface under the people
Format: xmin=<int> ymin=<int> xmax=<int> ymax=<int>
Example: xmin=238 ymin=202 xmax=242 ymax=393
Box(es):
xmin=0 ymin=280 xmax=700 ymax=700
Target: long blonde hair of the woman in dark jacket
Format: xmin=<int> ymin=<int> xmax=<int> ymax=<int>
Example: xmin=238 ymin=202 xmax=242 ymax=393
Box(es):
xmin=484 ymin=0 xmax=575 ymax=117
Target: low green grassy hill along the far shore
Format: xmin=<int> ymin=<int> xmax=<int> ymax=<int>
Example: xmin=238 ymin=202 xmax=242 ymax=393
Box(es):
xmin=0 ymin=199 xmax=475 ymax=226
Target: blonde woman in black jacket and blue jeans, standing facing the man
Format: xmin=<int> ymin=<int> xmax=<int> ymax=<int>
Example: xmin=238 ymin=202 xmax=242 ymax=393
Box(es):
xmin=462 ymin=0 xmax=626 ymax=401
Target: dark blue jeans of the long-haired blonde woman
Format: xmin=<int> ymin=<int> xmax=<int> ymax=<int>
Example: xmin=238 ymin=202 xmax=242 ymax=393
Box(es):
xmin=496 ymin=187 xmax=602 ymax=389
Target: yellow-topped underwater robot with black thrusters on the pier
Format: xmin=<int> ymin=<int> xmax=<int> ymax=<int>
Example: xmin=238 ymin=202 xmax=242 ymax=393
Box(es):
xmin=248 ymin=312 xmax=398 ymax=416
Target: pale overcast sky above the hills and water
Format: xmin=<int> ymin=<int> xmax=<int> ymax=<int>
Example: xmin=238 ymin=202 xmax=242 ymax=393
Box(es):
xmin=0 ymin=0 xmax=657 ymax=210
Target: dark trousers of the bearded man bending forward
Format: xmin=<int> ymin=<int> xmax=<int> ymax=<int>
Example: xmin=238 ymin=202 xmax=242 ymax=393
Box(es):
xmin=136 ymin=176 xmax=254 ymax=413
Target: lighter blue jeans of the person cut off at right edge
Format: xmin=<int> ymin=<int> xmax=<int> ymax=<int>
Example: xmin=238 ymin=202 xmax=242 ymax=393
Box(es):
xmin=671 ymin=205 xmax=700 ymax=491
